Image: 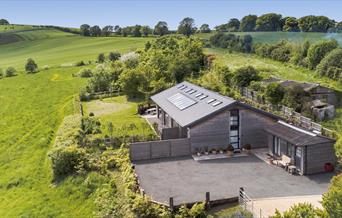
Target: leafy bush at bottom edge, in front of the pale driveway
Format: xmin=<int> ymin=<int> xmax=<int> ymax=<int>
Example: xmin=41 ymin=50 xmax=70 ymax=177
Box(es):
xmin=270 ymin=203 xmax=322 ymax=218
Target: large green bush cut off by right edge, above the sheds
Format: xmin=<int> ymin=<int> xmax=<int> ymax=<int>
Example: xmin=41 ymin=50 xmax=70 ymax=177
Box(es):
xmin=317 ymin=48 xmax=342 ymax=79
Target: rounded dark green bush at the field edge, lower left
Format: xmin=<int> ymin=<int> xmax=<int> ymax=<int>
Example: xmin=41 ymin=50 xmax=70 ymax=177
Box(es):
xmin=49 ymin=146 xmax=87 ymax=180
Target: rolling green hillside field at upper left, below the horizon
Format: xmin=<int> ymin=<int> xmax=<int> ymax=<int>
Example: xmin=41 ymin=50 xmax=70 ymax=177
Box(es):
xmin=0 ymin=30 xmax=152 ymax=69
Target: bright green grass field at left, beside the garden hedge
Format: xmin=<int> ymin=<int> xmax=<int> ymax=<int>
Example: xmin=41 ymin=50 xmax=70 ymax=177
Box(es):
xmin=0 ymin=68 xmax=99 ymax=217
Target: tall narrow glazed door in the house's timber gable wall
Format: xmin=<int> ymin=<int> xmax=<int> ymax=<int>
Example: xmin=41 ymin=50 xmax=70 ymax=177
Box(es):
xmin=229 ymin=110 xmax=240 ymax=149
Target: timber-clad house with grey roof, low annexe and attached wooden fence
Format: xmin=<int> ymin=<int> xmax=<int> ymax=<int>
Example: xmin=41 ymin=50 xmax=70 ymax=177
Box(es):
xmin=131 ymin=82 xmax=335 ymax=174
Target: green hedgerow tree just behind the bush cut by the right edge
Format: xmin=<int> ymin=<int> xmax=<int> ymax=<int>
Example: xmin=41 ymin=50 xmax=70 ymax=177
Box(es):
xmin=307 ymin=40 xmax=338 ymax=69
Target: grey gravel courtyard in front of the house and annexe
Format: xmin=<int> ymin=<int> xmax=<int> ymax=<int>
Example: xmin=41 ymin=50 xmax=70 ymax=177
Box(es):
xmin=135 ymin=155 xmax=333 ymax=204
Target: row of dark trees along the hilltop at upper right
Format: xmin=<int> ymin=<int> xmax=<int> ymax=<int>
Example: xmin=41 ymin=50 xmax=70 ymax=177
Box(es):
xmin=215 ymin=13 xmax=342 ymax=33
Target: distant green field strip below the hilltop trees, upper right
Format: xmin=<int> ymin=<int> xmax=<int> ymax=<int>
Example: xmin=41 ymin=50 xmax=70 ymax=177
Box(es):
xmin=198 ymin=32 xmax=342 ymax=45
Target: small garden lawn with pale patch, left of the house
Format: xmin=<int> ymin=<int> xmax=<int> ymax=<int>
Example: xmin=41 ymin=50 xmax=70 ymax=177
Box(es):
xmin=83 ymin=96 xmax=154 ymax=137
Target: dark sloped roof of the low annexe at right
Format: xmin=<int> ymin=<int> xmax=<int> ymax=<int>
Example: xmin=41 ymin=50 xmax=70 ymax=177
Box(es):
xmin=265 ymin=121 xmax=335 ymax=146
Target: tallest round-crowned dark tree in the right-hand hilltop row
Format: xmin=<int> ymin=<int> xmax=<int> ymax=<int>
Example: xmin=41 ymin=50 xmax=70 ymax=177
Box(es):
xmin=255 ymin=13 xmax=282 ymax=31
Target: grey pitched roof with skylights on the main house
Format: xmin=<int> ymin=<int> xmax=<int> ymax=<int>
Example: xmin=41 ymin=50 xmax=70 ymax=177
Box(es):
xmin=151 ymin=82 xmax=236 ymax=127
